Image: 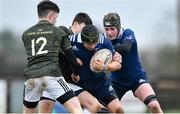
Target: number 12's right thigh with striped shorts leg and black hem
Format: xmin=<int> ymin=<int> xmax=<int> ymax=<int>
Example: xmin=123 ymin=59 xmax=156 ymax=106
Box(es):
xmin=47 ymin=77 xmax=82 ymax=113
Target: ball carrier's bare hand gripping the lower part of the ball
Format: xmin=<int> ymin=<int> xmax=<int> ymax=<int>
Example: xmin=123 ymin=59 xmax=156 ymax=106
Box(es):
xmin=92 ymin=60 xmax=104 ymax=71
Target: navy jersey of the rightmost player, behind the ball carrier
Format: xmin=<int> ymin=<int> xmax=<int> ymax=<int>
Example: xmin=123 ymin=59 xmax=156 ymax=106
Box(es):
xmin=104 ymin=29 xmax=146 ymax=84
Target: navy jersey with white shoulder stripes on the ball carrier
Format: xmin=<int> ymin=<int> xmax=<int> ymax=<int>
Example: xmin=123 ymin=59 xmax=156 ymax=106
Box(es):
xmin=70 ymin=33 xmax=115 ymax=81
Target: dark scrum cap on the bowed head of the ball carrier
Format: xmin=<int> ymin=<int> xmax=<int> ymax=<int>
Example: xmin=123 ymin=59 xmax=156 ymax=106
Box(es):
xmin=81 ymin=25 xmax=99 ymax=43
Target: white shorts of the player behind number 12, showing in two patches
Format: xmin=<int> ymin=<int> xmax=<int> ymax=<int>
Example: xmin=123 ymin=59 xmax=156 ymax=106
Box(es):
xmin=42 ymin=83 xmax=82 ymax=100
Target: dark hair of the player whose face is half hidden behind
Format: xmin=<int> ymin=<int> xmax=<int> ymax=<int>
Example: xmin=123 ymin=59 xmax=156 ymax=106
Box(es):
xmin=72 ymin=12 xmax=93 ymax=25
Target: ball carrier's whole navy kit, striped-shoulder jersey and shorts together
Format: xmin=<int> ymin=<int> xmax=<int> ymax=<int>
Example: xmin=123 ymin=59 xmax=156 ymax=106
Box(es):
xmin=70 ymin=33 xmax=116 ymax=105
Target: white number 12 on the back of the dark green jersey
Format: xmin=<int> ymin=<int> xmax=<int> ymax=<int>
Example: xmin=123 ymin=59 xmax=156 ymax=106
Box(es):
xmin=31 ymin=37 xmax=48 ymax=56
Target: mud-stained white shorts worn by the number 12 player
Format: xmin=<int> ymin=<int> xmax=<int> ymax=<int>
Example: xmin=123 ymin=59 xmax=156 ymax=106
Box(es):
xmin=24 ymin=76 xmax=72 ymax=102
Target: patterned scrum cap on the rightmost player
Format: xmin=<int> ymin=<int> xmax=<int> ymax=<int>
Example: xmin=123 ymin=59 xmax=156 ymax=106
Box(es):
xmin=103 ymin=13 xmax=121 ymax=30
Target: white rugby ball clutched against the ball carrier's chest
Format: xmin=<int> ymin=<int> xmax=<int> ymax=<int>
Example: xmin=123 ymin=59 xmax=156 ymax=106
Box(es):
xmin=90 ymin=49 xmax=112 ymax=73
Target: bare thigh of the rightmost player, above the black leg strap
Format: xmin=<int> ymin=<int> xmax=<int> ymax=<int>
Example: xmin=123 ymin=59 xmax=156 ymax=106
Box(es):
xmin=134 ymin=83 xmax=155 ymax=102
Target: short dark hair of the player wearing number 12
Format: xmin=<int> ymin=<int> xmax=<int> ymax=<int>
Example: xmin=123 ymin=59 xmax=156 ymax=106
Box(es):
xmin=37 ymin=0 xmax=60 ymax=17
